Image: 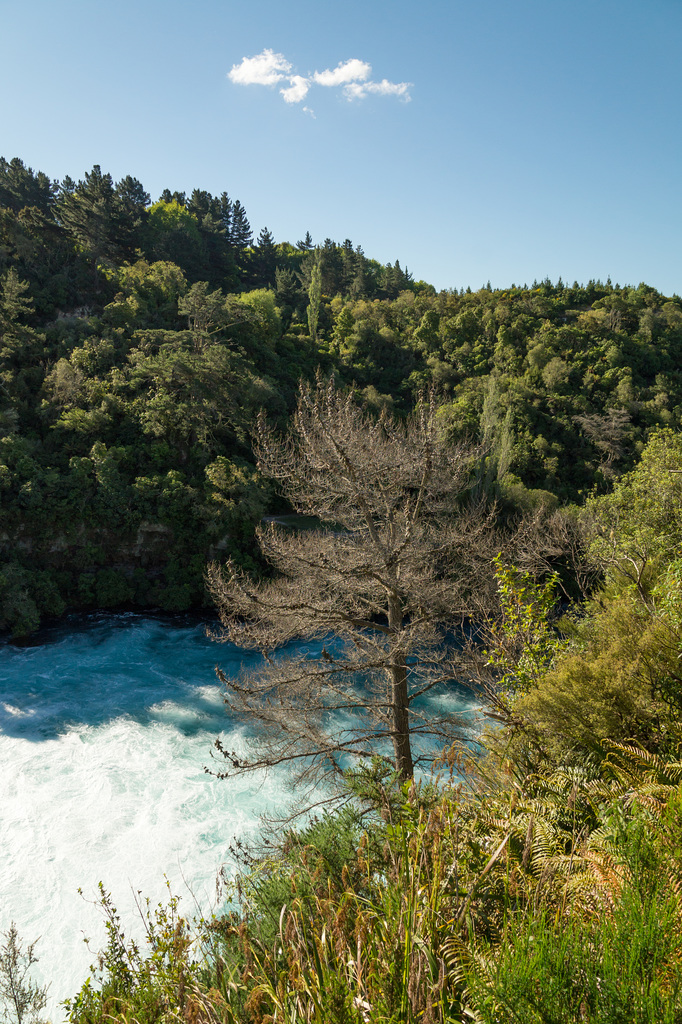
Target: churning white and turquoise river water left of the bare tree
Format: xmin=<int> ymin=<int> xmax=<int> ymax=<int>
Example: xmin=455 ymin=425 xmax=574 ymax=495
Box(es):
xmin=0 ymin=614 xmax=477 ymax=1021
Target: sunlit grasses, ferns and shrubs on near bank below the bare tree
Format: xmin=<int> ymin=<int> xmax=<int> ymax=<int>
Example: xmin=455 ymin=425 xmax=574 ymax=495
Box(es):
xmin=57 ymin=750 xmax=682 ymax=1024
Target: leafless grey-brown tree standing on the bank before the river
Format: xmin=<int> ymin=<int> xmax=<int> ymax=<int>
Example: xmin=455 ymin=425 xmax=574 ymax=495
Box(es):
xmin=208 ymin=379 xmax=499 ymax=781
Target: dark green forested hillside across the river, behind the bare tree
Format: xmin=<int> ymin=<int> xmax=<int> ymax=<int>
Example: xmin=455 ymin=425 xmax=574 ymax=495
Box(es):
xmin=0 ymin=152 xmax=682 ymax=635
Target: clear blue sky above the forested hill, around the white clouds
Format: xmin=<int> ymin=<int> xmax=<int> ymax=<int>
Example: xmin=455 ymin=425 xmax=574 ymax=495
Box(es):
xmin=0 ymin=0 xmax=682 ymax=294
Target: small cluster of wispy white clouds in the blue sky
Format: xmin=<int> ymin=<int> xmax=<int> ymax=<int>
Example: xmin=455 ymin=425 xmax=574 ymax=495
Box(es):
xmin=227 ymin=49 xmax=412 ymax=111
